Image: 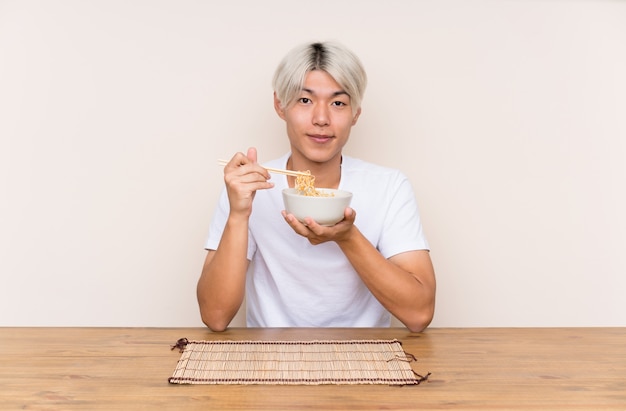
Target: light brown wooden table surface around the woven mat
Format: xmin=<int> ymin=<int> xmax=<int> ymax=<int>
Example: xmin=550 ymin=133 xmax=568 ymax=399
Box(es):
xmin=0 ymin=328 xmax=626 ymax=410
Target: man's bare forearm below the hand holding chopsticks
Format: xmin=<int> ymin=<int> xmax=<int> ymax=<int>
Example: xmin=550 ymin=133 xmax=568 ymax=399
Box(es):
xmin=197 ymin=217 xmax=248 ymax=331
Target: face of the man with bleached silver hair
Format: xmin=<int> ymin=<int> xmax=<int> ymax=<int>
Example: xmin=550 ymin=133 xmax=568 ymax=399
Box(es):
xmin=274 ymin=70 xmax=361 ymax=167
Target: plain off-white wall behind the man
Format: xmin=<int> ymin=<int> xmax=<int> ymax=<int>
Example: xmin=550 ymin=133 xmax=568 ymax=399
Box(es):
xmin=0 ymin=0 xmax=626 ymax=327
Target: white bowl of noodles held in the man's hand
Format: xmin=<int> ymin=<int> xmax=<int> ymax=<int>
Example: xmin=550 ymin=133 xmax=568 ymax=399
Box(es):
xmin=283 ymin=188 xmax=352 ymax=226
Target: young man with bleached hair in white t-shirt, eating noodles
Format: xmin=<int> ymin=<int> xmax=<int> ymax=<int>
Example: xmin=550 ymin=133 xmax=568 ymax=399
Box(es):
xmin=197 ymin=43 xmax=435 ymax=332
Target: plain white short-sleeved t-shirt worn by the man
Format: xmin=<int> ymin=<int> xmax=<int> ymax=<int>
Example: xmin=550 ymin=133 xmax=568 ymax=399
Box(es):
xmin=205 ymin=154 xmax=428 ymax=327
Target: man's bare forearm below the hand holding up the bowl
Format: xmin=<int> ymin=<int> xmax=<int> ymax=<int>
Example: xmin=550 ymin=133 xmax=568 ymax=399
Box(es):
xmin=338 ymin=226 xmax=435 ymax=331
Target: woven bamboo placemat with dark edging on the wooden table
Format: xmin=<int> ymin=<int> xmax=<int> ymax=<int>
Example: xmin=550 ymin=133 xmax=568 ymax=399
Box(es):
xmin=169 ymin=338 xmax=430 ymax=385
